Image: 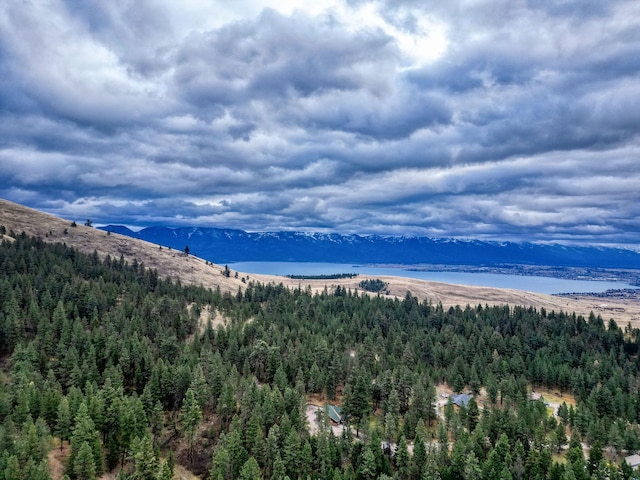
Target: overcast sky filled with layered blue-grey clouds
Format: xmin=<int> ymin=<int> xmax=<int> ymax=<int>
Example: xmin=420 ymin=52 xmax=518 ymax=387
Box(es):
xmin=0 ymin=0 xmax=640 ymax=248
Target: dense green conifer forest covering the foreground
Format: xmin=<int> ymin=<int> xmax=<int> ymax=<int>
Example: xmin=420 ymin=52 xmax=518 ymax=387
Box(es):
xmin=0 ymin=232 xmax=640 ymax=480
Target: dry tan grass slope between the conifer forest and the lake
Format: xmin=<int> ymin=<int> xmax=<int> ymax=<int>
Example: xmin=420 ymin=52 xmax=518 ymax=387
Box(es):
xmin=0 ymin=199 xmax=640 ymax=326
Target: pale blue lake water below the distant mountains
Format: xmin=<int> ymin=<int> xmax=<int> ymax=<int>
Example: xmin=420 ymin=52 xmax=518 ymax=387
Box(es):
xmin=229 ymin=262 xmax=636 ymax=294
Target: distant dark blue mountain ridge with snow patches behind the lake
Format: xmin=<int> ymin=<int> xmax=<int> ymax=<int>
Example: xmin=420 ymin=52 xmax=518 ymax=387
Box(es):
xmin=100 ymin=225 xmax=640 ymax=269
